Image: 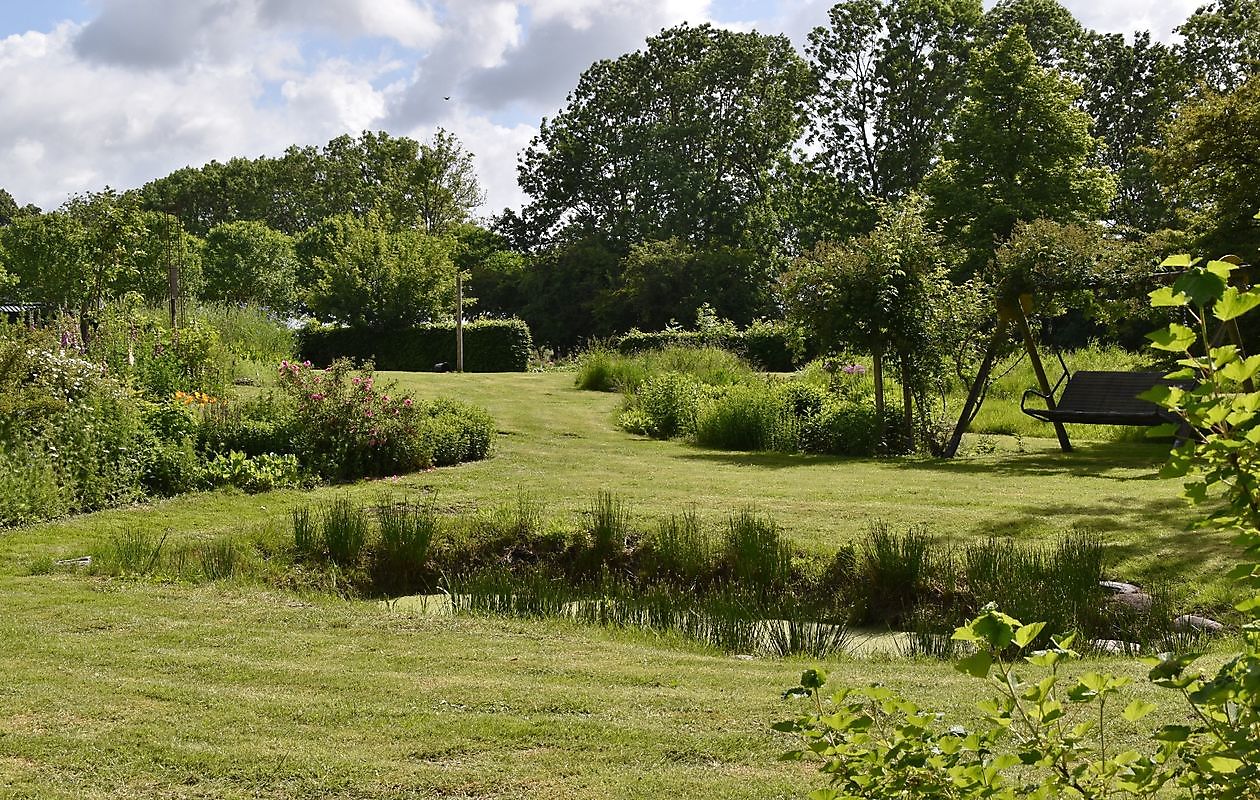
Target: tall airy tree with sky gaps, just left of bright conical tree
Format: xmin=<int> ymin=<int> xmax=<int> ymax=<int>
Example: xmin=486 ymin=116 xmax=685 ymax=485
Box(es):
xmin=806 ymin=0 xmax=982 ymax=209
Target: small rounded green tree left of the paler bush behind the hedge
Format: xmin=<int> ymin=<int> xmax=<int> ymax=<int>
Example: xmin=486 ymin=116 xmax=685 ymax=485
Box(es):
xmin=202 ymin=220 xmax=297 ymax=314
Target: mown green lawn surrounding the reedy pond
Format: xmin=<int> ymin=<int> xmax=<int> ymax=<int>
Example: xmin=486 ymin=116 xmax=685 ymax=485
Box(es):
xmin=0 ymin=373 xmax=1229 ymax=797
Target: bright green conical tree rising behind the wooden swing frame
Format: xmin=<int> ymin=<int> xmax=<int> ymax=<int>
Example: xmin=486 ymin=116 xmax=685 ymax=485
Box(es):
xmin=929 ymin=26 xmax=1114 ymax=272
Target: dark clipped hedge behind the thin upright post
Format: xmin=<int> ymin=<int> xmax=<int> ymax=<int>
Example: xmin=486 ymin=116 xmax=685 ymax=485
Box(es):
xmin=299 ymin=319 xmax=534 ymax=372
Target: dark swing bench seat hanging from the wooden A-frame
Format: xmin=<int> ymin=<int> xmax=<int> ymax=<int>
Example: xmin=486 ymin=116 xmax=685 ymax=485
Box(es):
xmin=1019 ymin=370 xmax=1182 ymax=426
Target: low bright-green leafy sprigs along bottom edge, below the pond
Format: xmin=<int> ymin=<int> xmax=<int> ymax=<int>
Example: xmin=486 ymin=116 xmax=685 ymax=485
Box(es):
xmin=774 ymin=606 xmax=1177 ymax=800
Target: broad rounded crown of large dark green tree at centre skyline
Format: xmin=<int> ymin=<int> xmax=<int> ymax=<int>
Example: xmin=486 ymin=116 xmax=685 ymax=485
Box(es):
xmin=518 ymin=25 xmax=813 ymax=253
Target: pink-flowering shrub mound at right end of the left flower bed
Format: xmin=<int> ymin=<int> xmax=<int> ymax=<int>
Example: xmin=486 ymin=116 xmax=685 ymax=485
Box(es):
xmin=280 ymin=359 xmax=494 ymax=480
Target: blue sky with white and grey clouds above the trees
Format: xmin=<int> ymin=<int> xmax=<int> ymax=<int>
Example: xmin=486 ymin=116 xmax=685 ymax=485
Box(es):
xmin=0 ymin=0 xmax=1205 ymax=217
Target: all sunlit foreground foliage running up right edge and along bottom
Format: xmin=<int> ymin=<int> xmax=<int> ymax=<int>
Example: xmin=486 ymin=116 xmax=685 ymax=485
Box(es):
xmin=775 ymin=225 xmax=1260 ymax=799
